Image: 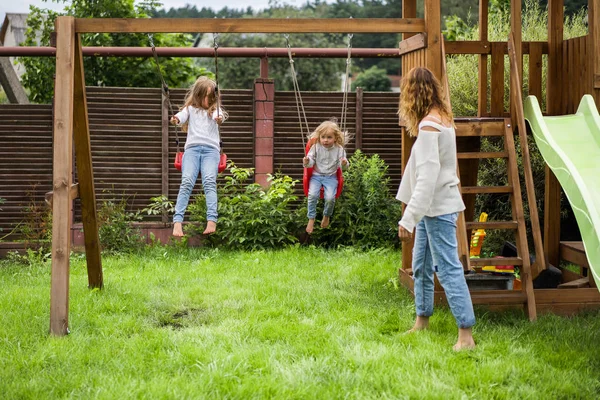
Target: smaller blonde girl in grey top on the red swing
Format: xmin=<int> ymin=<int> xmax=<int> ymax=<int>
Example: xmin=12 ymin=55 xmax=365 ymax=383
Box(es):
xmin=303 ymin=120 xmax=348 ymax=234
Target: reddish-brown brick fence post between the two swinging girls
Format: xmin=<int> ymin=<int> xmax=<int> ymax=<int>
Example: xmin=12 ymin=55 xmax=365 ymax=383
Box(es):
xmin=254 ymin=78 xmax=275 ymax=187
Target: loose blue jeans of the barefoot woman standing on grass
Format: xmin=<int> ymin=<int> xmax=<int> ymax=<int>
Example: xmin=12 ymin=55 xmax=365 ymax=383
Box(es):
xmin=412 ymin=213 xmax=475 ymax=328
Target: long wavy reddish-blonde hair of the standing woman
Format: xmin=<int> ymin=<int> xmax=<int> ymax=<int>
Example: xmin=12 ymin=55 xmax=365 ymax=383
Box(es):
xmin=398 ymin=67 xmax=453 ymax=137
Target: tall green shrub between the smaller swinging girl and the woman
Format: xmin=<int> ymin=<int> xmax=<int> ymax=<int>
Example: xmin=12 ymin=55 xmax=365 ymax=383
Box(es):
xmin=313 ymin=150 xmax=401 ymax=248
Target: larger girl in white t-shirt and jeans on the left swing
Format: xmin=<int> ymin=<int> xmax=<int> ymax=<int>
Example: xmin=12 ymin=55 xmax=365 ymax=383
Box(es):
xmin=171 ymin=76 xmax=228 ymax=237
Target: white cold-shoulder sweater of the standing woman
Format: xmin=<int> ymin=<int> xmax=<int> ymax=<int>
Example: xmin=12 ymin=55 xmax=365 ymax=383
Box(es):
xmin=396 ymin=121 xmax=465 ymax=232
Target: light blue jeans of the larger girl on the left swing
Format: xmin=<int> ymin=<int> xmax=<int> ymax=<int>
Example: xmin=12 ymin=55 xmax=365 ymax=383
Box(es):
xmin=173 ymin=145 xmax=220 ymax=222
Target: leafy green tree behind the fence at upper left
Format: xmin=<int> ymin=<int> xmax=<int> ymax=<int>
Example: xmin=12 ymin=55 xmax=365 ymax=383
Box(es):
xmin=19 ymin=0 xmax=207 ymax=103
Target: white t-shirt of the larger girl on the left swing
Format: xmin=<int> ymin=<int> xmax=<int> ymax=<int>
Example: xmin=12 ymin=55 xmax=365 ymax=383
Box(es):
xmin=175 ymin=106 xmax=223 ymax=150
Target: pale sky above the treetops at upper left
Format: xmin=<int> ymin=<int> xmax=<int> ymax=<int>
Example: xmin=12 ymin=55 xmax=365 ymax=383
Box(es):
xmin=0 ymin=0 xmax=290 ymax=24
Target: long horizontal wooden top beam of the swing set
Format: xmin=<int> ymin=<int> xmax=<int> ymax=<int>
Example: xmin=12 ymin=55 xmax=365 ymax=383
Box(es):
xmin=75 ymin=17 xmax=424 ymax=33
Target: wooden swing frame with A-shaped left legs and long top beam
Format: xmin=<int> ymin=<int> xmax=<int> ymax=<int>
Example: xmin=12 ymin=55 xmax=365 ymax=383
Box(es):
xmin=50 ymin=10 xmax=441 ymax=336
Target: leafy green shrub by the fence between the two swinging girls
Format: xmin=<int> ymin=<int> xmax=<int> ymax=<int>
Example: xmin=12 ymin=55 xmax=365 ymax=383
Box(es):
xmin=187 ymin=162 xmax=298 ymax=250
